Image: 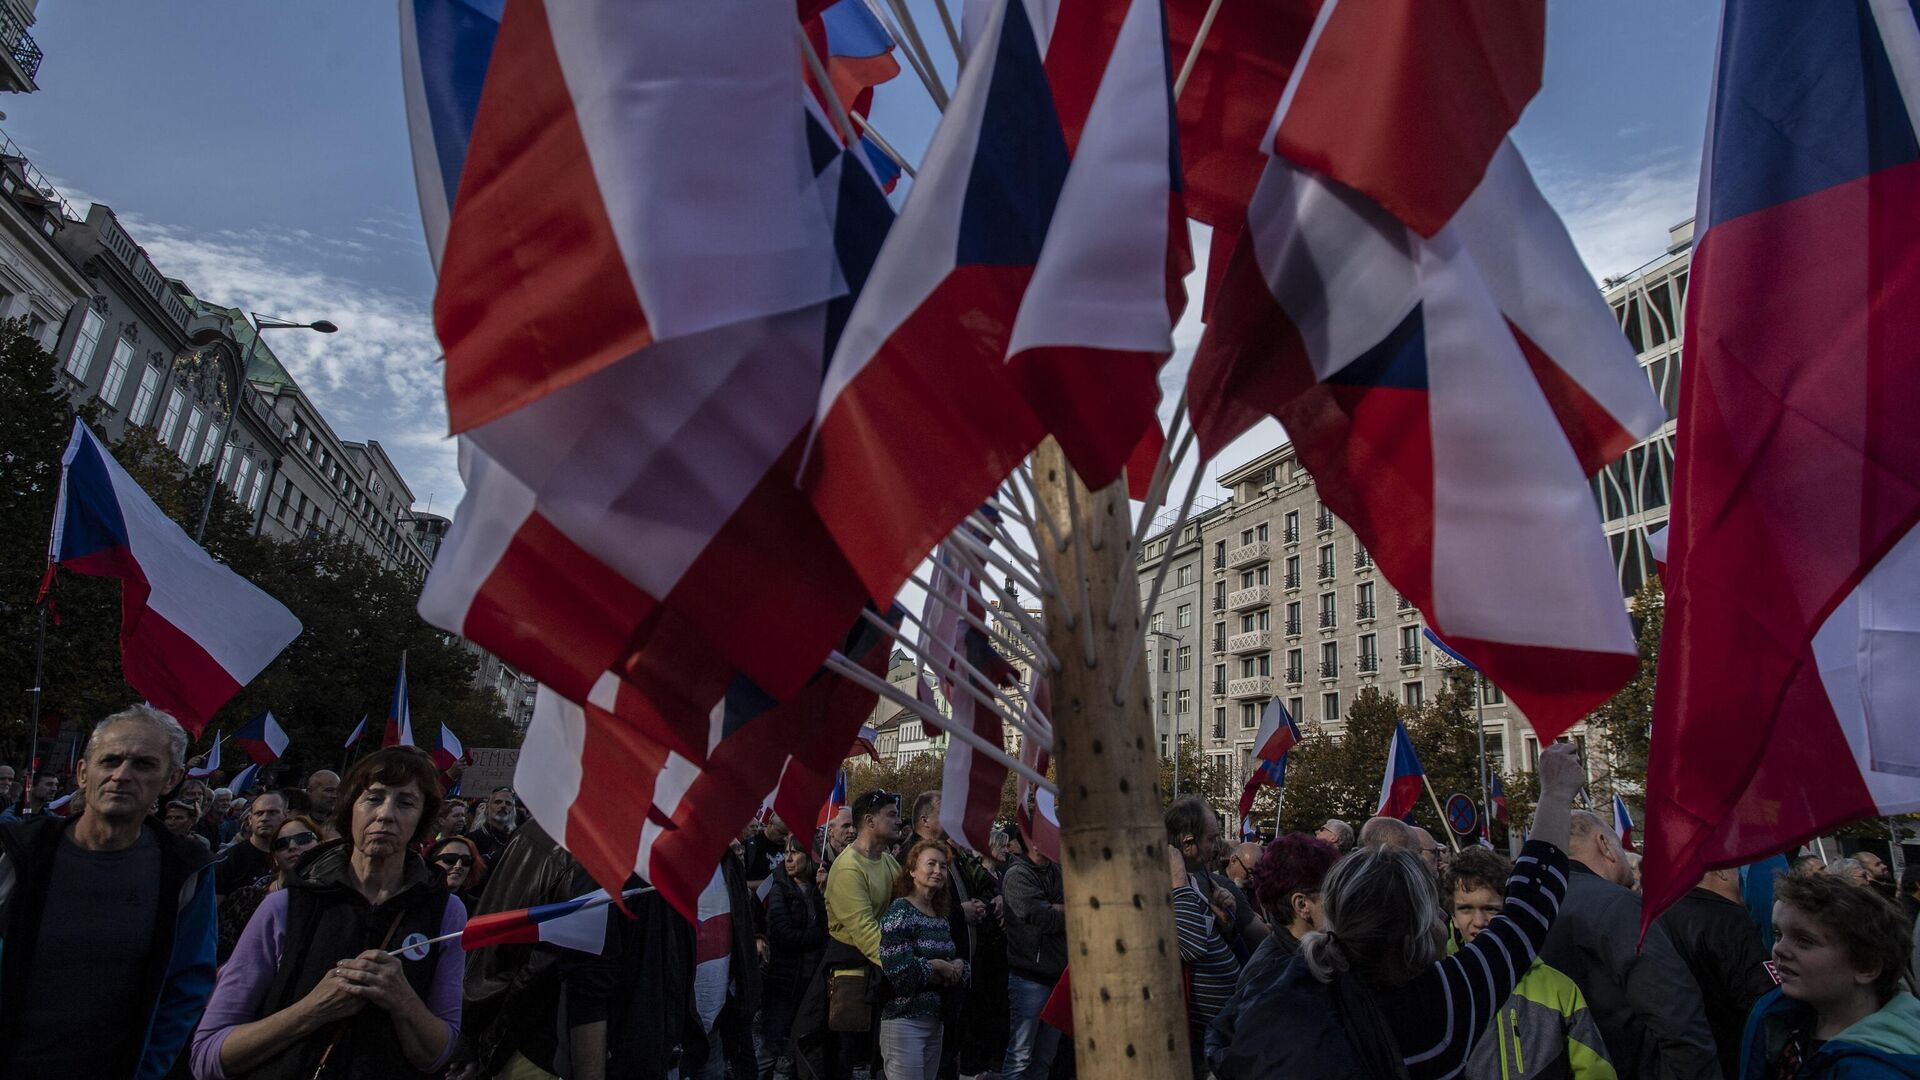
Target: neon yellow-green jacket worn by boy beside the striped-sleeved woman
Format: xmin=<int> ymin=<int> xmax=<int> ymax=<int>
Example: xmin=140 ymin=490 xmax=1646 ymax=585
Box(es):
xmin=1461 ymin=959 xmax=1615 ymax=1080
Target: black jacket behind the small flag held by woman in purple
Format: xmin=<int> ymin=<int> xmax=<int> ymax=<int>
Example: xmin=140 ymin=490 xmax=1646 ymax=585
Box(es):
xmin=461 ymin=821 xmax=595 ymax=1076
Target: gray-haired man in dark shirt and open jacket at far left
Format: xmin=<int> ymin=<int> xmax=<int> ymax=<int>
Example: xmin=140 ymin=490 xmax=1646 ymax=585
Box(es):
xmin=0 ymin=705 xmax=217 ymax=1080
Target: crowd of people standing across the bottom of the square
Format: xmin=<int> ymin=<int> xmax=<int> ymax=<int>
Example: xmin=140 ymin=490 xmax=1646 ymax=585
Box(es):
xmin=0 ymin=705 xmax=1920 ymax=1080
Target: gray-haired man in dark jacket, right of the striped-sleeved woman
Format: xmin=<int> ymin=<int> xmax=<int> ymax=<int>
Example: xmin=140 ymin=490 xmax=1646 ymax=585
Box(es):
xmin=1540 ymin=811 xmax=1720 ymax=1080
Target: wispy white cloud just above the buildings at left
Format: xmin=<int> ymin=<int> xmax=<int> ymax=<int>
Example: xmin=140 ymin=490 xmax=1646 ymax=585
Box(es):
xmin=123 ymin=215 xmax=463 ymax=511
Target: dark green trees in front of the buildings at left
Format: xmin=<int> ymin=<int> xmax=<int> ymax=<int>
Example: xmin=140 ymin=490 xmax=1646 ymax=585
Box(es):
xmin=0 ymin=325 xmax=516 ymax=776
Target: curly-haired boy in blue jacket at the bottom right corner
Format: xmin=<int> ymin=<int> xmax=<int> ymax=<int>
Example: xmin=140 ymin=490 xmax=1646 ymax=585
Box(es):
xmin=1740 ymin=872 xmax=1920 ymax=1080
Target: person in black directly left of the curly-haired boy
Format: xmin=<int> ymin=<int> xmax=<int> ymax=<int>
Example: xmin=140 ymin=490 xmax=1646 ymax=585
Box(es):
xmin=1661 ymin=869 xmax=1774 ymax=1080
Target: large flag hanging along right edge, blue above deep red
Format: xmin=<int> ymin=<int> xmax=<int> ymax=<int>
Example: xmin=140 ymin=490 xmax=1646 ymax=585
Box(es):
xmin=1644 ymin=0 xmax=1920 ymax=919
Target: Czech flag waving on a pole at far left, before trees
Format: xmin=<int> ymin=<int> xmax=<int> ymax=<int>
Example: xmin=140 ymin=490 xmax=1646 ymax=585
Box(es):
xmin=48 ymin=421 xmax=300 ymax=736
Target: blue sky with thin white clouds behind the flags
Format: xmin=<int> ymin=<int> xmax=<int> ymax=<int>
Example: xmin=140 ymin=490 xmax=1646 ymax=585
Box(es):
xmin=0 ymin=0 xmax=1718 ymax=509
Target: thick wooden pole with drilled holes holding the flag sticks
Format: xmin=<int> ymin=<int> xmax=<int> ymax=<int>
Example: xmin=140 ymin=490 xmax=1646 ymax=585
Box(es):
xmin=1033 ymin=438 xmax=1192 ymax=1080
